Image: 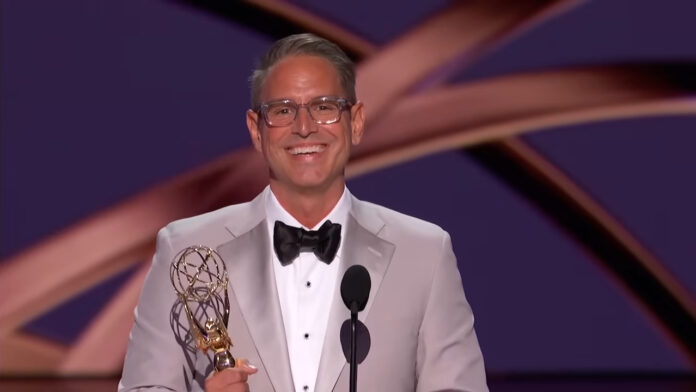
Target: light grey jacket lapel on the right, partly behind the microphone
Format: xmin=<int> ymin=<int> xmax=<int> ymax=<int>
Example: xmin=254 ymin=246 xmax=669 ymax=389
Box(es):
xmin=315 ymin=196 xmax=394 ymax=391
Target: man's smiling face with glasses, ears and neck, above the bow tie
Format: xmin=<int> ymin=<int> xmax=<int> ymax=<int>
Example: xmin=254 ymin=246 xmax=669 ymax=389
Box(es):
xmin=247 ymin=53 xmax=365 ymax=227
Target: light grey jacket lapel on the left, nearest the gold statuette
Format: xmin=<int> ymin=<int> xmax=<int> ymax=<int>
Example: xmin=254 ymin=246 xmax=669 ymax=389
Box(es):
xmin=218 ymin=190 xmax=293 ymax=391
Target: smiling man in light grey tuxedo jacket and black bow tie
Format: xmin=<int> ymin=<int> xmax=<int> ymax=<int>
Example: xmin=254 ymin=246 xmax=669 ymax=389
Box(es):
xmin=119 ymin=34 xmax=487 ymax=392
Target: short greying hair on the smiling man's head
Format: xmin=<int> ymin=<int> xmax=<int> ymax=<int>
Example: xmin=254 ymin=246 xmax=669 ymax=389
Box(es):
xmin=249 ymin=34 xmax=356 ymax=110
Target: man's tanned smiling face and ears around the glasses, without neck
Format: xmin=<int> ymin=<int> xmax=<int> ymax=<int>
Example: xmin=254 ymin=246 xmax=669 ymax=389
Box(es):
xmin=247 ymin=55 xmax=364 ymax=192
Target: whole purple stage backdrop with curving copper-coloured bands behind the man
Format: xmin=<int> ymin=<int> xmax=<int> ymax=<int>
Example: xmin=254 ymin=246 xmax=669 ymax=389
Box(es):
xmin=0 ymin=0 xmax=696 ymax=375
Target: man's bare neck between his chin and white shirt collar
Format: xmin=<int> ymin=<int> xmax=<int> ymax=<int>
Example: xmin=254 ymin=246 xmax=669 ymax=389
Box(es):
xmin=271 ymin=181 xmax=345 ymax=228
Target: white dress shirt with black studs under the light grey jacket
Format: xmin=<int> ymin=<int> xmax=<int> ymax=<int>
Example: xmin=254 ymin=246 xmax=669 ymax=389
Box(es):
xmin=266 ymin=188 xmax=351 ymax=392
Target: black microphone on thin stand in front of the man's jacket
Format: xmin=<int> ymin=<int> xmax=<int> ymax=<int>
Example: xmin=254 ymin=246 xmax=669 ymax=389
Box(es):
xmin=341 ymin=265 xmax=372 ymax=392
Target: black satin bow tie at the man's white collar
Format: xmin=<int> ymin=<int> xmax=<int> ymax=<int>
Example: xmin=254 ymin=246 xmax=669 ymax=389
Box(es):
xmin=273 ymin=220 xmax=341 ymax=266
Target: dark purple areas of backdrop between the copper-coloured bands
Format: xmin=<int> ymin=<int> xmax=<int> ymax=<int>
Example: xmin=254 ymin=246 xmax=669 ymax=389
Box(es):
xmin=0 ymin=0 xmax=696 ymax=372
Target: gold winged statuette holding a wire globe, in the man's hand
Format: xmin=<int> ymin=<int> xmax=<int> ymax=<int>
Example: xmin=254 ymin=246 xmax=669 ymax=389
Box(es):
xmin=169 ymin=246 xmax=235 ymax=372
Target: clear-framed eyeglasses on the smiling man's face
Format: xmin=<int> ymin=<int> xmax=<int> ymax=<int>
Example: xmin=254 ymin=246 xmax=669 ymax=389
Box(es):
xmin=257 ymin=97 xmax=353 ymax=127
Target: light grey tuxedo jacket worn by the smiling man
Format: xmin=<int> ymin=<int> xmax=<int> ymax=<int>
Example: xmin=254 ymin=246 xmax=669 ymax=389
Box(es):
xmin=119 ymin=187 xmax=487 ymax=392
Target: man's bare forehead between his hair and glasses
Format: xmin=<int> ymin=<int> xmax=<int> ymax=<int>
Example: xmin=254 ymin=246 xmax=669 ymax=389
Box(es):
xmin=261 ymin=55 xmax=344 ymax=102
